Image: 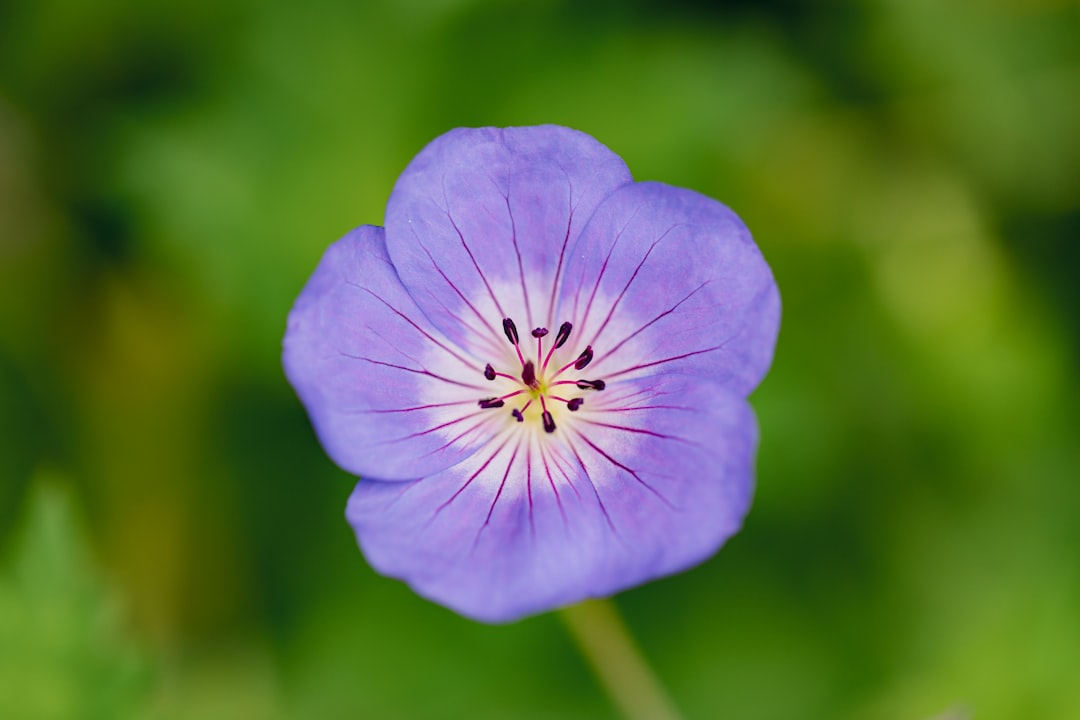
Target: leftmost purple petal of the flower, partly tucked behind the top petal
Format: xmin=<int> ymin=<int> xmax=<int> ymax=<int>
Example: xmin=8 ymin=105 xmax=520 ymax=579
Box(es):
xmin=283 ymin=226 xmax=490 ymax=479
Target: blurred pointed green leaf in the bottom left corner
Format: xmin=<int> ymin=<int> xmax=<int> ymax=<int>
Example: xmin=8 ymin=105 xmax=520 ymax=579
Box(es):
xmin=0 ymin=477 xmax=148 ymax=718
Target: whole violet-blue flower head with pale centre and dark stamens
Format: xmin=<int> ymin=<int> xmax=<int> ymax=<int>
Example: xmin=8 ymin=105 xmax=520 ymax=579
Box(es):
xmin=284 ymin=126 xmax=780 ymax=622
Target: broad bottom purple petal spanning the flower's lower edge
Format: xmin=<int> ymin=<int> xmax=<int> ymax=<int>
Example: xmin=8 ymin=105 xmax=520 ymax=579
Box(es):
xmin=347 ymin=376 xmax=757 ymax=622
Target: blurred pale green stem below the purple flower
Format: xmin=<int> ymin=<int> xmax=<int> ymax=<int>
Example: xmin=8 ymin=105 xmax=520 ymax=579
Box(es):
xmin=559 ymin=600 xmax=679 ymax=720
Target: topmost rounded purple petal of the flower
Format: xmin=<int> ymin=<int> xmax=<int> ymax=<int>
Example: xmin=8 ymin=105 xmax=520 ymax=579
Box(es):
xmin=387 ymin=125 xmax=631 ymax=347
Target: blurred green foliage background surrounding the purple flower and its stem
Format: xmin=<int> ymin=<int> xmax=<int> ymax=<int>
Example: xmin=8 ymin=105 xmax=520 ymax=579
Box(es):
xmin=0 ymin=0 xmax=1080 ymax=720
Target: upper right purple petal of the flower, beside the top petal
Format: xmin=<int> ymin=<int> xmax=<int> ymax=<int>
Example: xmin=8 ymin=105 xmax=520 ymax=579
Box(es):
xmin=557 ymin=182 xmax=780 ymax=395
